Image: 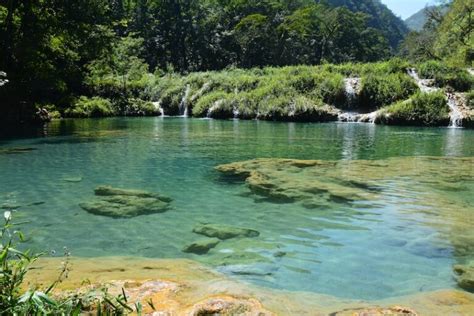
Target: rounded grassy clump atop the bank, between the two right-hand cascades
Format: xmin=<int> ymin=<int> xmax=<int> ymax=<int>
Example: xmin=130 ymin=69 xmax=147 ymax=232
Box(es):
xmin=360 ymin=73 xmax=418 ymax=108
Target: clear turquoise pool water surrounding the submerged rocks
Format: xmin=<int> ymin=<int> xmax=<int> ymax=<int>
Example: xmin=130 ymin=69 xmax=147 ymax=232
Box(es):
xmin=0 ymin=118 xmax=474 ymax=300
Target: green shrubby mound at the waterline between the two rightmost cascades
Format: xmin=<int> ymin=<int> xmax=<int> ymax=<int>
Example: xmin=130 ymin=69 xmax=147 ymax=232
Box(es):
xmin=386 ymin=92 xmax=449 ymax=126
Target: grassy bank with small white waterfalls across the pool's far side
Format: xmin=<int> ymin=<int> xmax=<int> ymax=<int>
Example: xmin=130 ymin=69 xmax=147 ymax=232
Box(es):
xmin=53 ymin=59 xmax=474 ymax=128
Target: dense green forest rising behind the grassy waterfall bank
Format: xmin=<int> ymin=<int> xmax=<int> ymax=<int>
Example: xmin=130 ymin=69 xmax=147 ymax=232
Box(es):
xmin=0 ymin=0 xmax=472 ymax=121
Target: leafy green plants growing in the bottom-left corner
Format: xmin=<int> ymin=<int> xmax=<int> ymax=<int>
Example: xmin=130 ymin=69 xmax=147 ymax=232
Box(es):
xmin=0 ymin=211 xmax=142 ymax=315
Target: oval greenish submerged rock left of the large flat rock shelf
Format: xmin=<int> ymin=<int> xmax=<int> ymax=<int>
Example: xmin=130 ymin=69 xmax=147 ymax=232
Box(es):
xmin=79 ymin=186 xmax=171 ymax=218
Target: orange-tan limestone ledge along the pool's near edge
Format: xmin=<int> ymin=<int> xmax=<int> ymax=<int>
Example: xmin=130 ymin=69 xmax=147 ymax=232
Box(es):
xmin=29 ymin=257 xmax=474 ymax=315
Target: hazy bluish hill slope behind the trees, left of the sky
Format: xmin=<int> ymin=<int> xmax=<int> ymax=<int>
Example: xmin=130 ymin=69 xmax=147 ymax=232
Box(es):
xmin=327 ymin=0 xmax=409 ymax=48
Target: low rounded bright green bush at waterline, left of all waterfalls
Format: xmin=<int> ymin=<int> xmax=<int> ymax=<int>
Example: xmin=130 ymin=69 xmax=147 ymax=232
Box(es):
xmin=65 ymin=96 xmax=118 ymax=118
